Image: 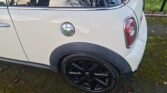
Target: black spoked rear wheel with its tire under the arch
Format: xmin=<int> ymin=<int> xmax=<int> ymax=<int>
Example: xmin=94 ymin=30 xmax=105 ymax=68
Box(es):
xmin=61 ymin=54 xmax=119 ymax=93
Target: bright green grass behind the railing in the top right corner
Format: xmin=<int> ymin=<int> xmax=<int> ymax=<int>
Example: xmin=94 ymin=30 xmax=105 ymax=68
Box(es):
xmin=145 ymin=0 xmax=167 ymax=13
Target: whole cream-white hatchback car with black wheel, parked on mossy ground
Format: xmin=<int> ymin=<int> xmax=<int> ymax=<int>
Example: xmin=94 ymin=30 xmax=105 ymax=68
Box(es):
xmin=0 ymin=0 xmax=147 ymax=93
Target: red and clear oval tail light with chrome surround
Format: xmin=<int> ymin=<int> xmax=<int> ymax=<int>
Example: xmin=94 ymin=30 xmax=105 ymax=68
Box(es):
xmin=124 ymin=17 xmax=137 ymax=48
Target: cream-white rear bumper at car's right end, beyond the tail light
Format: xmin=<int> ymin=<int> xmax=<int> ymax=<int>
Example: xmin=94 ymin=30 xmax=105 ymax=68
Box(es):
xmin=125 ymin=14 xmax=147 ymax=72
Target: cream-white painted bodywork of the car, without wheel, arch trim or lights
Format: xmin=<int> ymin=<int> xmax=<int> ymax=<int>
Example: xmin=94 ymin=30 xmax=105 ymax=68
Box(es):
xmin=0 ymin=0 xmax=147 ymax=92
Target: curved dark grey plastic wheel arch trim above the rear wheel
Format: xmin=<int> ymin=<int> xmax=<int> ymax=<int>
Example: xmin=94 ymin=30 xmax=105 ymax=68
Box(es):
xmin=50 ymin=42 xmax=132 ymax=76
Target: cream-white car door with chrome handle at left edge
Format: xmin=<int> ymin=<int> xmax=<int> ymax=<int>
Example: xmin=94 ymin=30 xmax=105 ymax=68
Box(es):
xmin=0 ymin=0 xmax=27 ymax=61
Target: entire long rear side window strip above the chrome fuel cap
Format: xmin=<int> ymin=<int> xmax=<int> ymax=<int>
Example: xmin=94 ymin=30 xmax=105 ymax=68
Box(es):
xmin=9 ymin=0 xmax=122 ymax=7
